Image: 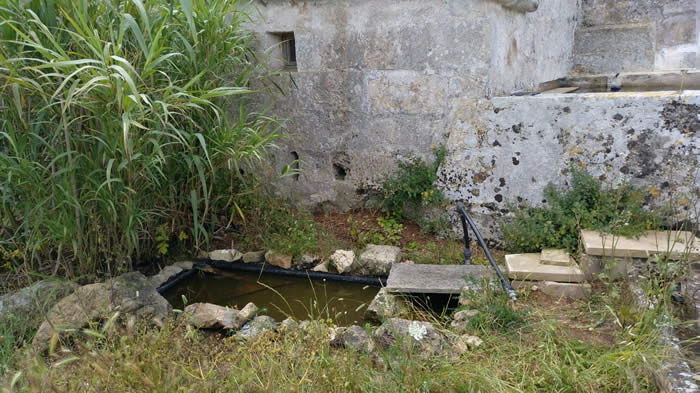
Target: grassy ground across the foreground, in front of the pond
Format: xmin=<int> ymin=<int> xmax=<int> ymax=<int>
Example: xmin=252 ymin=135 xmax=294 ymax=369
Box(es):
xmin=5 ymin=284 xmax=662 ymax=392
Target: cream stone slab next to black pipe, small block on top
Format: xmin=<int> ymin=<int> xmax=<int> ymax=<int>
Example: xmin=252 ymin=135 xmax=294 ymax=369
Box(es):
xmin=506 ymin=253 xmax=586 ymax=282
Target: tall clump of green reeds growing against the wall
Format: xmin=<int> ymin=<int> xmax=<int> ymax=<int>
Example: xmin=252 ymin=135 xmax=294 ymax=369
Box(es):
xmin=0 ymin=0 xmax=283 ymax=275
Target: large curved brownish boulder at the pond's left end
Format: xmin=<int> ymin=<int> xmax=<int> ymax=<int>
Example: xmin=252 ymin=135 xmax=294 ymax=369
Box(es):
xmin=32 ymin=272 xmax=171 ymax=350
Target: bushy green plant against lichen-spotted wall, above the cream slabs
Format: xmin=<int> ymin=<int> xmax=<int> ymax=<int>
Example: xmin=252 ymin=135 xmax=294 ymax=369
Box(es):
xmin=501 ymin=166 xmax=654 ymax=252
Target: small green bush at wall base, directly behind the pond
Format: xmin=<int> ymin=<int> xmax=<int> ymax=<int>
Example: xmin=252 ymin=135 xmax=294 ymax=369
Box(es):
xmin=381 ymin=146 xmax=446 ymax=217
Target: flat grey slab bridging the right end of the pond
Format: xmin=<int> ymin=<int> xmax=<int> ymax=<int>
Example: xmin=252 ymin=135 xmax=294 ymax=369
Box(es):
xmin=386 ymin=263 xmax=494 ymax=294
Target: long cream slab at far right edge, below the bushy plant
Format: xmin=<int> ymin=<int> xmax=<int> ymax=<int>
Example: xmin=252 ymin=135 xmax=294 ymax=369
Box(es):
xmin=581 ymin=231 xmax=700 ymax=259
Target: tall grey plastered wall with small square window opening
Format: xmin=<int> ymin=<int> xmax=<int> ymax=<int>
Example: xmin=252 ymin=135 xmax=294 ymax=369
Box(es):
xmin=246 ymin=0 xmax=578 ymax=209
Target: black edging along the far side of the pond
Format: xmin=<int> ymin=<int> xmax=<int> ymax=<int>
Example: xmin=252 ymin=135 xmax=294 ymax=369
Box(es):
xmin=200 ymin=260 xmax=386 ymax=286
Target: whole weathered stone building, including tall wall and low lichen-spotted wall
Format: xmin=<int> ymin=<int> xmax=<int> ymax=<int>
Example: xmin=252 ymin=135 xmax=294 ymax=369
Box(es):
xmin=243 ymin=0 xmax=700 ymax=236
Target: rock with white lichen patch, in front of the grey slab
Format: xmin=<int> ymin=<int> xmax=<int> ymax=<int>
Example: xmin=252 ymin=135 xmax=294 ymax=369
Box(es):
xmin=374 ymin=318 xmax=445 ymax=359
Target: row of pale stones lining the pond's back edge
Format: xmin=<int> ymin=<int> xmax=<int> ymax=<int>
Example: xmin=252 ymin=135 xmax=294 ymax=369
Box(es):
xmin=207 ymin=244 xmax=401 ymax=276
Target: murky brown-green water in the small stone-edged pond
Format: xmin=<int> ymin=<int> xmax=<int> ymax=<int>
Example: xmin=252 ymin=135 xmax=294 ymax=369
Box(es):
xmin=163 ymin=272 xmax=379 ymax=326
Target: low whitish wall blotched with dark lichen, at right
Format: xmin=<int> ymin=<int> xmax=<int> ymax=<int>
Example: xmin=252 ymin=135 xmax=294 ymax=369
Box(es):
xmin=439 ymin=91 xmax=700 ymax=238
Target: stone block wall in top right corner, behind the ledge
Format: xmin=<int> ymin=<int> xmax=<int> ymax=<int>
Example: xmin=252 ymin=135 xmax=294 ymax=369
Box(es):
xmin=573 ymin=0 xmax=700 ymax=74
